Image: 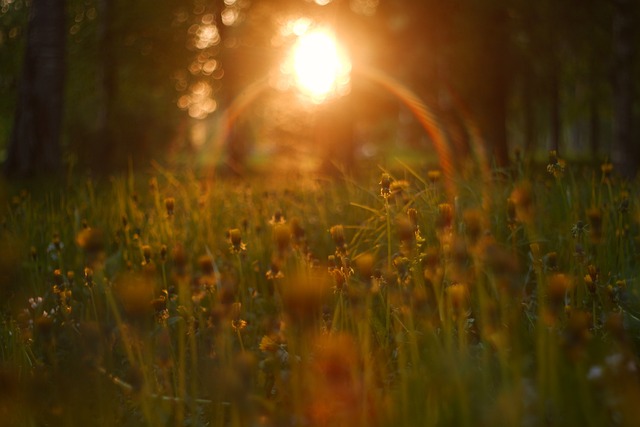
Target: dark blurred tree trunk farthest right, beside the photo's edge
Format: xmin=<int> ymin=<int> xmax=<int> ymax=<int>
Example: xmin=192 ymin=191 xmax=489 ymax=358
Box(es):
xmin=611 ymin=0 xmax=640 ymax=178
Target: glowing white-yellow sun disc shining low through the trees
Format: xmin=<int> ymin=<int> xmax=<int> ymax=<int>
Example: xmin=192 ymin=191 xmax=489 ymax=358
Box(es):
xmin=293 ymin=30 xmax=351 ymax=102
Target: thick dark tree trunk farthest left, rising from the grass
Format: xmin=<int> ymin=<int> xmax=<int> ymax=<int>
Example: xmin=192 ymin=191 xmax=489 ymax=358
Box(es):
xmin=5 ymin=0 xmax=66 ymax=177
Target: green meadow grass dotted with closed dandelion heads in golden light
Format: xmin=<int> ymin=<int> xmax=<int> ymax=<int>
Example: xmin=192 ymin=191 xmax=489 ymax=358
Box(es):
xmin=0 ymin=155 xmax=640 ymax=426
